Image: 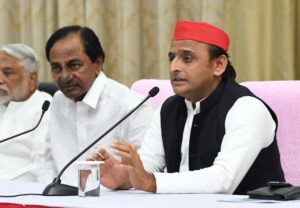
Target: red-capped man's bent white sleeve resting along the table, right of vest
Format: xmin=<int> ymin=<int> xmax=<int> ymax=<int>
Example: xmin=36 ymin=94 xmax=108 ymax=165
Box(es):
xmin=154 ymin=96 xmax=276 ymax=194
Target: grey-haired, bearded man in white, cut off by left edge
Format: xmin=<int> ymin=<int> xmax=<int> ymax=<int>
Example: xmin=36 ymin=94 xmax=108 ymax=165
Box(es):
xmin=0 ymin=44 xmax=55 ymax=182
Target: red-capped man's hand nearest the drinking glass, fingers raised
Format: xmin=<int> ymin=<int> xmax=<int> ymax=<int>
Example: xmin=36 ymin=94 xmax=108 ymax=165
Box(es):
xmin=90 ymin=148 xmax=132 ymax=189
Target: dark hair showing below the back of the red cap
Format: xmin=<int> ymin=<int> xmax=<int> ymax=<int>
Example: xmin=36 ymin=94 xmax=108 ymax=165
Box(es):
xmin=208 ymin=45 xmax=236 ymax=79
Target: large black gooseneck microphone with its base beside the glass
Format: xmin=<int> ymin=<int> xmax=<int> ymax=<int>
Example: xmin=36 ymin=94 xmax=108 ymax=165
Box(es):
xmin=43 ymin=87 xmax=159 ymax=196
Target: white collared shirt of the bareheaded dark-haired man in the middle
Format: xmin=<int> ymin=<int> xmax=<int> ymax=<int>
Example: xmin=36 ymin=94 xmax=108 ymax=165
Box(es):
xmin=50 ymin=72 xmax=154 ymax=185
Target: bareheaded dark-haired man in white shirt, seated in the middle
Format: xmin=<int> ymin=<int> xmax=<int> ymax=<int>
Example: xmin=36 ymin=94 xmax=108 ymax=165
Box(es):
xmin=46 ymin=25 xmax=154 ymax=185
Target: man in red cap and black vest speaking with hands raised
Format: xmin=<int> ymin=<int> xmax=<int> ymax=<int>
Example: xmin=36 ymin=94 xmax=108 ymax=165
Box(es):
xmin=93 ymin=21 xmax=284 ymax=194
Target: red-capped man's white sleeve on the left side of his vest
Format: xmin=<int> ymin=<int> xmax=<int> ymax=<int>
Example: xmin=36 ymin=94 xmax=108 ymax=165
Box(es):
xmin=139 ymin=108 xmax=166 ymax=172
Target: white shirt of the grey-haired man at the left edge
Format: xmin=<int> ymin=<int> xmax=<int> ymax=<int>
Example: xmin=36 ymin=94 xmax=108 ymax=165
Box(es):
xmin=0 ymin=90 xmax=56 ymax=182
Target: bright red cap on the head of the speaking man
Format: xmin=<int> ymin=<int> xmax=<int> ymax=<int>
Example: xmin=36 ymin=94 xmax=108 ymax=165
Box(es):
xmin=173 ymin=21 xmax=229 ymax=51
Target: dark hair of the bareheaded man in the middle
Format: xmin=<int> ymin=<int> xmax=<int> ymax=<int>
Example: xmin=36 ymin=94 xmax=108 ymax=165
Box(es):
xmin=46 ymin=25 xmax=105 ymax=63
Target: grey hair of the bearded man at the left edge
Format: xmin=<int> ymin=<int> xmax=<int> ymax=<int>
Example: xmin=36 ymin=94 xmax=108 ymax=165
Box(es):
xmin=0 ymin=43 xmax=40 ymax=73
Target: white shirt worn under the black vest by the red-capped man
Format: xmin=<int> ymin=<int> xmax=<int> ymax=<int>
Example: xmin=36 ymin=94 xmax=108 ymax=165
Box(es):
xmin=139 ymin=96 xmax=276 ymax=194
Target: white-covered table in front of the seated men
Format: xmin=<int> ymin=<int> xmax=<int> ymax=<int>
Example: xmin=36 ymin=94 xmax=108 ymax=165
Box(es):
xmin=0 ymin=181 xmax=300 ymax=208
